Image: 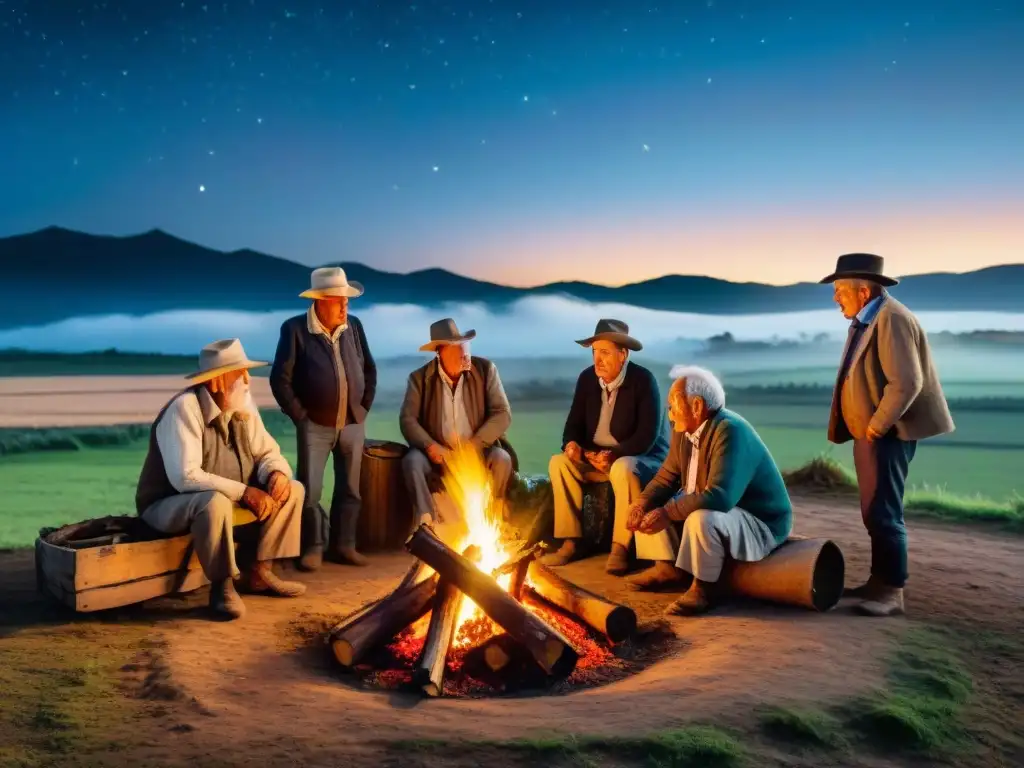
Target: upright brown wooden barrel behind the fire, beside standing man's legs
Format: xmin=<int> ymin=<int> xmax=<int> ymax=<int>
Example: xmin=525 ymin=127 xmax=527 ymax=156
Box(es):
xmin=355 ymin=440 xmax=413 ymax=552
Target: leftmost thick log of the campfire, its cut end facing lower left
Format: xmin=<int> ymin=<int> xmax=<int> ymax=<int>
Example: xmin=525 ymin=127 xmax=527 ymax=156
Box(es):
xmin=331 ymin=562 xmax=438 ymax=667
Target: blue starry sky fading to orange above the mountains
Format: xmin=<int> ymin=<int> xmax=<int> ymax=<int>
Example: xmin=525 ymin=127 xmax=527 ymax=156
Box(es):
xmin=0 ymin=0 xmax=1024 ymax=286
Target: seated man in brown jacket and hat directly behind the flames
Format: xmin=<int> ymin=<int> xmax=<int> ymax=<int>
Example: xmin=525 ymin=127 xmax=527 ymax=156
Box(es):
xmin=398 ymin=317 xmax=516 ymax=522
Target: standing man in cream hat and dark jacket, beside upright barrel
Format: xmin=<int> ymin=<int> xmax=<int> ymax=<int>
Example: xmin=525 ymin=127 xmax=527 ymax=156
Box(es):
xmin=270 ymin=266 xmax=377 ymax=570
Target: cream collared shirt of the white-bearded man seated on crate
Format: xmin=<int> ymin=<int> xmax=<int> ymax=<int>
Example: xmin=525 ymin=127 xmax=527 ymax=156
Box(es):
xmin=157 ymin=387 xmax=292 ymax=502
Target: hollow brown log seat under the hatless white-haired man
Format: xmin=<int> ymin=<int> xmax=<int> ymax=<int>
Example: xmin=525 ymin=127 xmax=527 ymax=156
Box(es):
xmin=722 ymin=537 xmax=846 ymax=612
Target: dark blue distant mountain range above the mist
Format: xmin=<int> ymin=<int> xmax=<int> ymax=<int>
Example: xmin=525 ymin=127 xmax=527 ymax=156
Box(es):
xmin=0 ymin=227 xmax=1024 ymax=329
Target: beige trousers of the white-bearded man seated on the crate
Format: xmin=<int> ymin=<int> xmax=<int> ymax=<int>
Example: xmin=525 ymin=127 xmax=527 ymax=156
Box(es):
xmin=141 ymin=480 xmax=305 ymax=583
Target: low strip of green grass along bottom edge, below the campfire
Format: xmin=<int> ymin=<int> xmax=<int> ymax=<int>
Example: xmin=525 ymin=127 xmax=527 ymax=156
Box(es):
xmin=389 ymin=725 xmax=746 ymax=768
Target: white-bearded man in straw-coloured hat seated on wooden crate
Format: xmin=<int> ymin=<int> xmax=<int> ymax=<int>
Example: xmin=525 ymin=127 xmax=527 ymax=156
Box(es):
xmin=135 ymin=339 xmax=306 ymax=618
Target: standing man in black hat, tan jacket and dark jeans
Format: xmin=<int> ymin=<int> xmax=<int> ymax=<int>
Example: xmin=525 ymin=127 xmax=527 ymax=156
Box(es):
xmin=821 ymin=253 xmax=953 ymax=616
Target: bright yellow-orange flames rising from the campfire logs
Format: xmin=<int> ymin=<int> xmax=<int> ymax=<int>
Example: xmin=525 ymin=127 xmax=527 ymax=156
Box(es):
xmin=441 ymin=443 xmax=512 ymax=648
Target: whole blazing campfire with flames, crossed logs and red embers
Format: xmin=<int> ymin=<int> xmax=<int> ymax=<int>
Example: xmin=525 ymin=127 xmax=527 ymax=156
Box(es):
xmin=330 ymin=446 xmax=637 ymax=696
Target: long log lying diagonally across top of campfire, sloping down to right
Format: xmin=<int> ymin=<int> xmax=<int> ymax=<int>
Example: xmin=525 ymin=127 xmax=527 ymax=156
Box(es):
xmin=406 ymin=525 xmax=580 ymax=677
